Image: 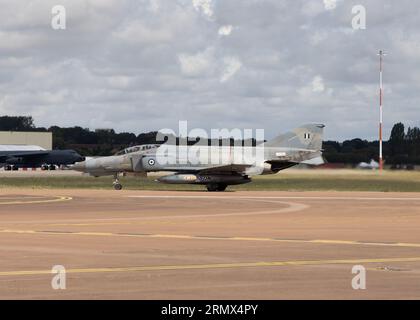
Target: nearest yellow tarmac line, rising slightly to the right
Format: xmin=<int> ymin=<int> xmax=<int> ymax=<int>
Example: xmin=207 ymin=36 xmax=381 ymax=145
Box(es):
xmin=0 ymin=257 xmax=420 ymax=277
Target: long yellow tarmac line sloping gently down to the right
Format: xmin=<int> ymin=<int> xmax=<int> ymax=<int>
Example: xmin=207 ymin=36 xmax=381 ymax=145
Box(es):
xmin=0 ymin=229 xmax=420 ymax=248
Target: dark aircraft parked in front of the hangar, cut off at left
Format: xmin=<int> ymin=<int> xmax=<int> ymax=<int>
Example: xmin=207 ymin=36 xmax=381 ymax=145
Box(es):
xmin=0 ymin=145 xmax=85 ymax=171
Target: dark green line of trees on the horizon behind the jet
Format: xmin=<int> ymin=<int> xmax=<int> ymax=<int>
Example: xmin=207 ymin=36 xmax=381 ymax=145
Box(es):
xmin=0 ymin=116 xmax=420 ymax=166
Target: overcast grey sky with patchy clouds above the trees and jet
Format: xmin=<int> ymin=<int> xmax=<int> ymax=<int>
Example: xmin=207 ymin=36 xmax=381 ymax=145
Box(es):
xmin=0 ymin=0 xmax=420 ymax=140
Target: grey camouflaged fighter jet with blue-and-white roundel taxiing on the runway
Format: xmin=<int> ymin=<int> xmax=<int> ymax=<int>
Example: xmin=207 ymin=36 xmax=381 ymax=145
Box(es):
xmin=71 ymin=124 xmax=324 ymax=191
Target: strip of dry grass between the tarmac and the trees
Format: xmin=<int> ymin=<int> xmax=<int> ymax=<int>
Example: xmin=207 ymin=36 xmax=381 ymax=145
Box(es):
xmin=0 ymin=170 xmax=420 ymax=192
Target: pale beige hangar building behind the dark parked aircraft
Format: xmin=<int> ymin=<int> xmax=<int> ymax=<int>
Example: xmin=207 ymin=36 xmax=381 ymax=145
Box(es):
xmin=0 ymin=131 xmax=52 ymax=150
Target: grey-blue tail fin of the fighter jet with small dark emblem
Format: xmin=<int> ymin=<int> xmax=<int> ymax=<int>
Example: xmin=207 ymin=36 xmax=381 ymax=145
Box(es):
xmin=265 ymin=124 xmax=325 ymax=151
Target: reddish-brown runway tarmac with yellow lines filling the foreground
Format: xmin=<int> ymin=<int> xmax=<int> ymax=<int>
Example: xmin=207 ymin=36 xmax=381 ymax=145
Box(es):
xmin=0 ymin=189 xmax=420 ymax=299
